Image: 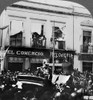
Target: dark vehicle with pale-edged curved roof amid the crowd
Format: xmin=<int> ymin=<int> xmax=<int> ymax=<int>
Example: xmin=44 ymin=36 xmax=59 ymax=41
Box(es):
xmin=17 ymin=75 xmax=55 ymax=100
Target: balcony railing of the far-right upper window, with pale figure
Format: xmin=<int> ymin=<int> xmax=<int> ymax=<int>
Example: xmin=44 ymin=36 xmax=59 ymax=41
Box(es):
xmin=80 ymin=45 xmax=93 ymax=53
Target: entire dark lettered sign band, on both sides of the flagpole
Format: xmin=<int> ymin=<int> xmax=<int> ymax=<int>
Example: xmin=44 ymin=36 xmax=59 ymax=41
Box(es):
xmin=7 ymin=47 xmax=74 ymax=59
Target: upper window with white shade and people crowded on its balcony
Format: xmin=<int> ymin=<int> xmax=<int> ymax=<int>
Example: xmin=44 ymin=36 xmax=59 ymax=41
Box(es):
xmin=31 ymin=21 xmax=46 ymax=48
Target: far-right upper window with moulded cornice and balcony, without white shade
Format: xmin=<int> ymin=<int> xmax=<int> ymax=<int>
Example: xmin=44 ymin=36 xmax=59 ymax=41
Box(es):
xmin=80 ymin=20 xmax=93 ymax=53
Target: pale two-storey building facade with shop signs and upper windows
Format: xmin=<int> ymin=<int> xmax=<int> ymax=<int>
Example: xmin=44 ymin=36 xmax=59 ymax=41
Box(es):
xmin=0 ymin=1 xmax=93 ymax=72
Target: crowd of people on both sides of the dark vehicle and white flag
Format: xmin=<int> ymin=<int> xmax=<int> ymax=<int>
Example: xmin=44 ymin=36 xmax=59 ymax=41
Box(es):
xmin=0 ymin=66 xmax=93 ymax=100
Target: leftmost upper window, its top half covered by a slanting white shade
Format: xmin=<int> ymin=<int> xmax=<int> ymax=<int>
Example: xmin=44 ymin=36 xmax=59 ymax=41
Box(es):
xmin=10 ymin=20 xmax=23 ymax=46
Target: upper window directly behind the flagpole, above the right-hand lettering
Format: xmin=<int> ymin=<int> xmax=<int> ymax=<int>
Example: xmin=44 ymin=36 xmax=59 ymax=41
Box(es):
xmin=50 ymin=23 xmax=65 ymax=49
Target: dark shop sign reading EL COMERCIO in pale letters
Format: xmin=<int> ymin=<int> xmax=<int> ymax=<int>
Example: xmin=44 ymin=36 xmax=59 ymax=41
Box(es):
xmin=7 ymin=46 xmax=50 ymax=58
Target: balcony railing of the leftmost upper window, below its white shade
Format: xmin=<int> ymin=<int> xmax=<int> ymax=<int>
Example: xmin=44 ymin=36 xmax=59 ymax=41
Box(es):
xmin=10 ymin=37 xmax=25 ymax=47
